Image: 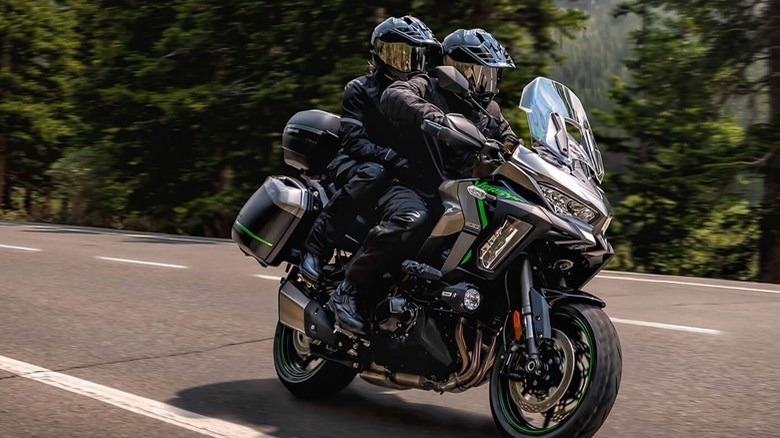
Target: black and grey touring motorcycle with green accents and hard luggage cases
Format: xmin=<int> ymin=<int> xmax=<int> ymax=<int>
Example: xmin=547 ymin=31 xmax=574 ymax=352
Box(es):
xmin=232 ymin=67 xmax=622 ymax=437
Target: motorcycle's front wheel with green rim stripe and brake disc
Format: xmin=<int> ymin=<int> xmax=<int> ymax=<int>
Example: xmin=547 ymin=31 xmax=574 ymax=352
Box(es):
xmin=490 ymin=304 xmax=623 ymax=438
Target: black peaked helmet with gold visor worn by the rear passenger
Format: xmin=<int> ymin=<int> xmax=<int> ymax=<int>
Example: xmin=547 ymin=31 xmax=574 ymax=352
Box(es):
xmin=371 ymin=15 xmax=441 ymax=80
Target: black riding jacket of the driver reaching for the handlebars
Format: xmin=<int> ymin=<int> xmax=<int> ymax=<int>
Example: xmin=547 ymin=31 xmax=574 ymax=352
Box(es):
xmin=380 ymin=75 xmax=517 ymax=191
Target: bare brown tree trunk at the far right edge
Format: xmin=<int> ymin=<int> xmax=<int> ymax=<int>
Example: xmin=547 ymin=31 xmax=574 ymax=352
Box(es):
xmin=759 ymin=0 xmax=780 ymax=283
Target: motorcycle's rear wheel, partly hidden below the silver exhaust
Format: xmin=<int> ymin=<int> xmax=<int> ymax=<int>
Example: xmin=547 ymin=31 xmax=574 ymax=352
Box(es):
xmin=274 ymin=322 xmax=357 ymax=399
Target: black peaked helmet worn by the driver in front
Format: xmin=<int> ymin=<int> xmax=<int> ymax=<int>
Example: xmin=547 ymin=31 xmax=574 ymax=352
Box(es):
xmin=441 ymin=29 xmax=515 ymax=100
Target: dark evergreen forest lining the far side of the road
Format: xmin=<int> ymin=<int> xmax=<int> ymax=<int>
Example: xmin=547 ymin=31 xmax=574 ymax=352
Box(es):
xmin=0 ymin=0 xmax=780 ymax=282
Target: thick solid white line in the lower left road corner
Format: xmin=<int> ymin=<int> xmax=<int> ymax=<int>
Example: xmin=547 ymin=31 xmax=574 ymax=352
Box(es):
xmin=0 ymin=356 xmax=271 ymax=438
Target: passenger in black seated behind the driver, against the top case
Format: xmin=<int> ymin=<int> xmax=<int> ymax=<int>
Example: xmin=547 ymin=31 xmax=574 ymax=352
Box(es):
xmin=301 ymin=15 xmax=441 ymax=286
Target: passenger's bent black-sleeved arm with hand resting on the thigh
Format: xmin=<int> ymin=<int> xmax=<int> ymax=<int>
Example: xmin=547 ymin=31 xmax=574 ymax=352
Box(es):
xmin=339 ymin=78 xmax=399 ymax=167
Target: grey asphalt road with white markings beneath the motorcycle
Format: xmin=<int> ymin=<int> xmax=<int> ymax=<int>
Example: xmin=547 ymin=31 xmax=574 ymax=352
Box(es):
xmin=0 ymin=222 xmax=780 ymax=438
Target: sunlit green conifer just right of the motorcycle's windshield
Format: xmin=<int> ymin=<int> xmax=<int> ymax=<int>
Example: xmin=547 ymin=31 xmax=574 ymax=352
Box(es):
xmin=605 ymin=3 xmax=756 ymax=276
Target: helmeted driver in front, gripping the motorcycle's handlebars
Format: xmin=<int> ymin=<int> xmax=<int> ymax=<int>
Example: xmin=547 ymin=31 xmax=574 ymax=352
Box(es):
xmin=331 ymin=29 xmax=521 ymax=333
